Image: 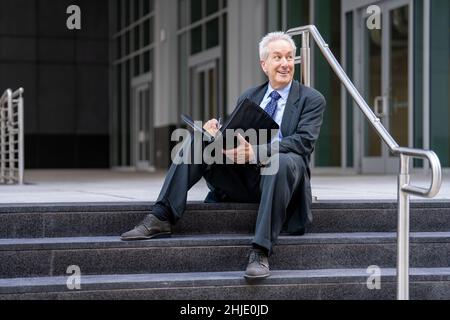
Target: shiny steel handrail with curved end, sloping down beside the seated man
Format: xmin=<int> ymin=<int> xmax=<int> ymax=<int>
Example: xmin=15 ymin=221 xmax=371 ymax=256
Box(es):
xmin=287 ymin=25 xmax=442 ymax=300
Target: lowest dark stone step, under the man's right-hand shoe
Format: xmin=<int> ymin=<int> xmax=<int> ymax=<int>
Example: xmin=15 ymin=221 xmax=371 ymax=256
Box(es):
xmin=0 ymin=268 xmax=450 ymax=300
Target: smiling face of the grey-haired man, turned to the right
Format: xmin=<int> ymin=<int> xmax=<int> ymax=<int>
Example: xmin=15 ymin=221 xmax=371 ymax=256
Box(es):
xmin=261 ymin=40 xmax=295 ymax=90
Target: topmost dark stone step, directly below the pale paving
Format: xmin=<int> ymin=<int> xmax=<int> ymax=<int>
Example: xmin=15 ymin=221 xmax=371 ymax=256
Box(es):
xmin=0 ymin=201 xmax=450 ymax=238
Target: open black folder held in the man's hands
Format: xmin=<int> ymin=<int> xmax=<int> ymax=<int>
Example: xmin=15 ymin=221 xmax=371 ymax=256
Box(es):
xmin=181 ymin=99 xmax=279 ymax=147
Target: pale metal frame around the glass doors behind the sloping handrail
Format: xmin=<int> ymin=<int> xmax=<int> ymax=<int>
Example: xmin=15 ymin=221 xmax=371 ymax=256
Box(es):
xmin=341 ymin=0 xmax=414 ymax=174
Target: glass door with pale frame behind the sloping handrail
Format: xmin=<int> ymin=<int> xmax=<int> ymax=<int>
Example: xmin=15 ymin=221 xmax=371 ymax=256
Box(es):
xmin=357 ymin=0 xmax=412 ymax=173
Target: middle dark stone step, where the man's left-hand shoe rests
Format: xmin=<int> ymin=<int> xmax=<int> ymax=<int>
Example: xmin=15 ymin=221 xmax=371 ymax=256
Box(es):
xmin=0 ymin=232 xmax=450 ymax=278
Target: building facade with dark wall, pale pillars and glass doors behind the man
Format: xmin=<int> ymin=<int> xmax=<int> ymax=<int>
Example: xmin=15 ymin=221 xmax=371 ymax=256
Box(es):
xmin=0 ymin=0 xmax=450 ymax=174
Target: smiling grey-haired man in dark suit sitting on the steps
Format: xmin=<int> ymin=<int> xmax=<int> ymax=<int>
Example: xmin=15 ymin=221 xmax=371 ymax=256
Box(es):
xmin=121 ymin=32 xmax=325 ymax=279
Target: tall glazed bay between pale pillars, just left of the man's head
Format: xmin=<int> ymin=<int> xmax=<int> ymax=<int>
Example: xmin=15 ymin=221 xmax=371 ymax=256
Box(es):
xmin=178 ymin=0 xmax=227 ymax=127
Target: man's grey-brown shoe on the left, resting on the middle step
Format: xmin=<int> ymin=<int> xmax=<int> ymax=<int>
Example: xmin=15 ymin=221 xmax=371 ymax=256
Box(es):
xmin=120 ymin=214 xmax=172 ymax=241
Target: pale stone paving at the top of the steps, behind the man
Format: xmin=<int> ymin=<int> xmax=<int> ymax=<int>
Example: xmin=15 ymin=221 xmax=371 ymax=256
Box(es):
xmin=0 ymin=170 xmax=450 ymax=204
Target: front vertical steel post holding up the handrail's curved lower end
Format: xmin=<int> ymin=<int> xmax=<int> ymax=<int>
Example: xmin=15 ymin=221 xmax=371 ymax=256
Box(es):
xmin=397 ymin=154 xmax=410 ymax=300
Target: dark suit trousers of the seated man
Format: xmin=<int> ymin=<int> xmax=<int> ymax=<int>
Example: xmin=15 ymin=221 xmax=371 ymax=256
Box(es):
xmin=157 ymin=139 xmax=306 ymax=253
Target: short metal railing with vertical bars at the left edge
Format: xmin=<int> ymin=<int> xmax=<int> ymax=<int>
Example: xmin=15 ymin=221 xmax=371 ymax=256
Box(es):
xmin=0 ymin=88 xmax=24 ymax=184
